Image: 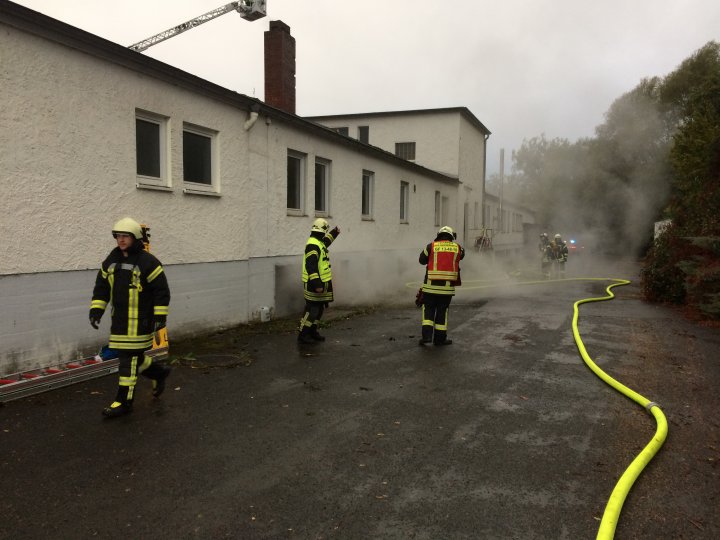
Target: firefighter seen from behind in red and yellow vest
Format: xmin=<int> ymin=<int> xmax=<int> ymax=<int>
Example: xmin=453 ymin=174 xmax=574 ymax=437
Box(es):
xmin=419 ymin=226 xmax=465 ymax=346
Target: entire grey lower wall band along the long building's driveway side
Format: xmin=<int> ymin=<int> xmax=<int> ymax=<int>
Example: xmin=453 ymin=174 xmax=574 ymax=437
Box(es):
xmin=0 ymin=246 xmax=424 ymax=375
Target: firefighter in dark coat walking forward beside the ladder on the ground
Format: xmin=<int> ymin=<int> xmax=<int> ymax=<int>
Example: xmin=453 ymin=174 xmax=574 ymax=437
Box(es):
xmin=90 ymin=218 xmax=170 ymax=418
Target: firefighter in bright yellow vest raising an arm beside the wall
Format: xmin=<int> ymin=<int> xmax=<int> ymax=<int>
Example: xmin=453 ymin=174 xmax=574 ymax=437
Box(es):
xmin=298 ymin=218 xmax=340 ymax=343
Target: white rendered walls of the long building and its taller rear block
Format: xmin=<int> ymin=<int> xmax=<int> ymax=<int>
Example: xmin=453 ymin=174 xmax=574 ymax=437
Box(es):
xmin=0 ymin=2 xmax=489 ymax=374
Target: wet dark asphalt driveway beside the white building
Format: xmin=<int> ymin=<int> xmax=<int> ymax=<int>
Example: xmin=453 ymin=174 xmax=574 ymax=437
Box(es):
xmin=0 ymin=264 xmax=720 ymax=540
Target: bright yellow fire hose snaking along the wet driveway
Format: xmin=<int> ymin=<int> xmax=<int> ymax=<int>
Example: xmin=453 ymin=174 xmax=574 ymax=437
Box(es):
xmin=408 ymin=278 xmax=668 ymax=540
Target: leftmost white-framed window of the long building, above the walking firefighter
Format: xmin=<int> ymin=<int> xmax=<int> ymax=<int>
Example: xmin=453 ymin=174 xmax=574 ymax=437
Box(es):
xmin=135 ymin=111 xmax=170 ymax=187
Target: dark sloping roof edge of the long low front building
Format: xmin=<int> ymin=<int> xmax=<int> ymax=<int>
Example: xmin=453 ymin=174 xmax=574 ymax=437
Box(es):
xmin=0 ymin=0 xmax=456 ymax=185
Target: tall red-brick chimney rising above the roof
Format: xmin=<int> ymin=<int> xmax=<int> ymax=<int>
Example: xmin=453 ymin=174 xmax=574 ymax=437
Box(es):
xmin=265 ymin=21 xmax=295 ymax=114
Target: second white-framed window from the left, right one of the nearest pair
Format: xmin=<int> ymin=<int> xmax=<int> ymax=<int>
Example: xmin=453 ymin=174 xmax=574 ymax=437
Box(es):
xmin=183 ymin=124 xmax=220 ymax=193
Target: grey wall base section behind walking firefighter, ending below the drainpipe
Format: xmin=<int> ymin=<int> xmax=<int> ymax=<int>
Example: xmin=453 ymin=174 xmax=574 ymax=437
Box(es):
xmin=0 ymin=261 xmax=249 ymax=375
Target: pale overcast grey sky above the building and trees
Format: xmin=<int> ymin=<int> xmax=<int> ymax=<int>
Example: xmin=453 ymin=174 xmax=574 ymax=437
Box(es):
xmin=11 ymin=0 xmax=720 ymax=174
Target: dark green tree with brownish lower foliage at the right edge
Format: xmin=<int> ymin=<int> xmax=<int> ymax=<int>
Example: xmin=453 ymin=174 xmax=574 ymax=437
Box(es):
xmin=643 ymin=41 xmax=720 ymax=318
